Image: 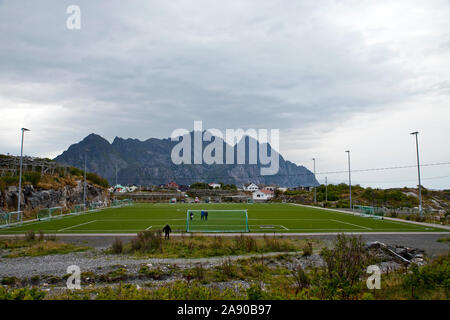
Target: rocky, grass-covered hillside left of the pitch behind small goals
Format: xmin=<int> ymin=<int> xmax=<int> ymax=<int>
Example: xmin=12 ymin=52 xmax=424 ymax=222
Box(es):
xmin=0 ymin=155 xmax=109 ymax=217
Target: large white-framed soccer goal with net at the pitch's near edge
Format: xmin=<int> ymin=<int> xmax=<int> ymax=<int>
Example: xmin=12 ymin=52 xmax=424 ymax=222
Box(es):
xmin=186 ymin=209 xmax=250 ymax=232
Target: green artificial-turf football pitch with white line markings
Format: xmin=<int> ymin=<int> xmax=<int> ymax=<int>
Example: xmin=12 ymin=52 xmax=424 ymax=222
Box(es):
xmin=0 ymin=203 xmax=447 ymax=234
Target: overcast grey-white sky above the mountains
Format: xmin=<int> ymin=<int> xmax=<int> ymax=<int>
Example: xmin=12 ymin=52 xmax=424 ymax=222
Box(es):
xmin=0 ymin=0 xmax=450 ymax=188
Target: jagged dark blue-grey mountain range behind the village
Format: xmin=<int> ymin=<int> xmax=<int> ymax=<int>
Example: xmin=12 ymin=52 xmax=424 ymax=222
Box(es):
xmin=54 ymin=132 xmax=319 ymax=187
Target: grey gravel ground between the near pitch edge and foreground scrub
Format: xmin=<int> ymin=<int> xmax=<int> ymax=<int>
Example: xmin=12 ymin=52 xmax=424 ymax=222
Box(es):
xmin=0 ymin=234 xmax=450 ymax=279
